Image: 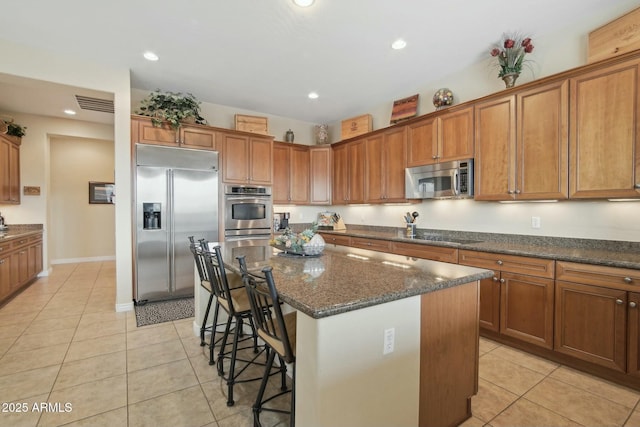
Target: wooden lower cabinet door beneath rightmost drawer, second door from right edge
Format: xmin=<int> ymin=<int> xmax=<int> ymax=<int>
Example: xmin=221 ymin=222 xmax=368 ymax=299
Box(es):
xmin=554 ymin=281 xmax=627 ymax=372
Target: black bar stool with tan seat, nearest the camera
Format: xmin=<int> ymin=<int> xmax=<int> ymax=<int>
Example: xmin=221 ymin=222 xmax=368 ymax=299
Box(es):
xmin=237 ymin=256 xmax=296 ymax=427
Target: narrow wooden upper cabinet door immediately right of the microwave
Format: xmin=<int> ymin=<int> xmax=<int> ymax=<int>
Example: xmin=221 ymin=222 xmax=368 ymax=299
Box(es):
xmin=474 ymin=95 xmax=516 ymax=200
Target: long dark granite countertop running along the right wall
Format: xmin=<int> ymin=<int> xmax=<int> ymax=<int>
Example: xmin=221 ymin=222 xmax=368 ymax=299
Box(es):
xmin=322 ymin=226 xmax=640 ymax=269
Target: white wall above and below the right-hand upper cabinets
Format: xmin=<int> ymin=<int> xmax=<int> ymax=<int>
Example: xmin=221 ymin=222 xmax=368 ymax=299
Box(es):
xmin=276 ymin=0 xmax=640 ymax=242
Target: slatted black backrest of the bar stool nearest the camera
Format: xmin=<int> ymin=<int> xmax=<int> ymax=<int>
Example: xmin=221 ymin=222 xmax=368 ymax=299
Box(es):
xmin=238 ymin=256 xmax=295 ymax=363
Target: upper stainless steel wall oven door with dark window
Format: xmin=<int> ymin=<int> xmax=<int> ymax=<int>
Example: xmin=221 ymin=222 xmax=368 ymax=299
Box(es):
xmin=224 ymin=195 xmax=273 ymax=231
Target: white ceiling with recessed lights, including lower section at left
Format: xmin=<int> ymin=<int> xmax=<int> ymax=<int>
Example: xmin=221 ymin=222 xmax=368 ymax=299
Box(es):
xmin=0 ymin=0 xmax=634 ymax=123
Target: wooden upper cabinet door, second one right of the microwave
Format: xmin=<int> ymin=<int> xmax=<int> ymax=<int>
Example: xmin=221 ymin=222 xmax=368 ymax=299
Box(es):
xmin=516 ymin=80 xmax=569 ymax=200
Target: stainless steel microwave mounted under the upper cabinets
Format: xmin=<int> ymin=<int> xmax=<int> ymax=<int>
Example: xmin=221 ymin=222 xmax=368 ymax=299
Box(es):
xmin=405 ymin=159 xmax=473 ymax=199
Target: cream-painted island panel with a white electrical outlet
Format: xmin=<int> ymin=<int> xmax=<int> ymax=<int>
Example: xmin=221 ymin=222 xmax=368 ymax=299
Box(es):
xmin=296 ymin=296 xmax=420 ymax=427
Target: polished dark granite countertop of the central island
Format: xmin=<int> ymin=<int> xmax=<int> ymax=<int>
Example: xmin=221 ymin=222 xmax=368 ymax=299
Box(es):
xmin=212 ymin=241 xmax=493 ymax=319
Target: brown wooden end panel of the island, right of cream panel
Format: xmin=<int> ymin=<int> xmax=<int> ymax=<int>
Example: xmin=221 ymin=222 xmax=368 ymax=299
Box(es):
xmin=420 ymin=281 xmax=479 ymax=427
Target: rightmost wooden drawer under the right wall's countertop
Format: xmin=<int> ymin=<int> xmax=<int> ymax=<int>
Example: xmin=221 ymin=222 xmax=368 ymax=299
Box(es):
xmin=556 ymin=261 xmax=640 ymax=291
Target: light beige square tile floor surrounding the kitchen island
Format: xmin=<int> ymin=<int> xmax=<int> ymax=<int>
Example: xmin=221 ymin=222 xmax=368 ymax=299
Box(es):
xmin=0 ymin=262 xmax=640 ymax=427
